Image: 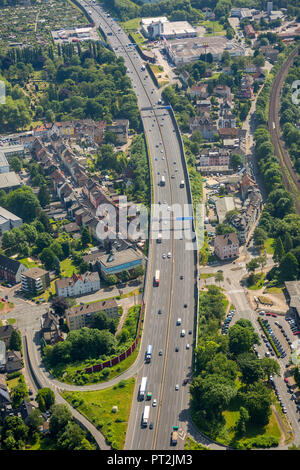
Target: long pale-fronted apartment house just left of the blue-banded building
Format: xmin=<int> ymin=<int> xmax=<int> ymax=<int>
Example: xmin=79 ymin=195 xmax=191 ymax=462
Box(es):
xmin=55 ymin=272 xmax=100 ymax=297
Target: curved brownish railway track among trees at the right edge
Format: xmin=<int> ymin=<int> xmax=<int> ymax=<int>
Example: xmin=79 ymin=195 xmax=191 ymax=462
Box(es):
xmin=268 ymin=47 xmax=300 ymax=215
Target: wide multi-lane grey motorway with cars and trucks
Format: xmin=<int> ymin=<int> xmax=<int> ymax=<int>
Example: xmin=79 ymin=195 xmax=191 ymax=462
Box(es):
xmin=80 ymin=1 xmax=197 ymax=449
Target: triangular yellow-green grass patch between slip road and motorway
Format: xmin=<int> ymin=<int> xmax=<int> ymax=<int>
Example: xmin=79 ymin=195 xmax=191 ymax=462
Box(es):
xmin=62 ymin=378 xmax=135 ymax=450
